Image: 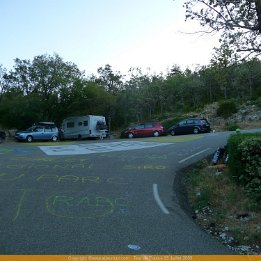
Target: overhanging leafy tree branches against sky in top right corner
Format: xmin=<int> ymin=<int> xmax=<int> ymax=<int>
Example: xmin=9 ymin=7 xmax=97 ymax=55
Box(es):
xmin=184 ymin=0 xmax=261 ymax=56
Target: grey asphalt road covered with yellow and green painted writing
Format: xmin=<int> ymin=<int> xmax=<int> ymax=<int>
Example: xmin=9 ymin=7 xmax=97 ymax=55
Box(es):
xmin=0 ymin=133 xmax=238 ymax=254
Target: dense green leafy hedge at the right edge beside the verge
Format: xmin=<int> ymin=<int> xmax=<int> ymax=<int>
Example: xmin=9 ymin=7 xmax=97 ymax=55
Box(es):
xmin=225 ymin=134 xmax=261 ymax=207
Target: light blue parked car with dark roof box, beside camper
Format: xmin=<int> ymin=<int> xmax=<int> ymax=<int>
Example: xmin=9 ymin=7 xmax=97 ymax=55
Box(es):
xmin=15 ymin=122 xmax=59 ymax=142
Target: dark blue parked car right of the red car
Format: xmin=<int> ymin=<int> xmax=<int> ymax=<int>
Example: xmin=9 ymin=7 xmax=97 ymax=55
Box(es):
xmin=168 ymin=118 xmax=211 ymax=136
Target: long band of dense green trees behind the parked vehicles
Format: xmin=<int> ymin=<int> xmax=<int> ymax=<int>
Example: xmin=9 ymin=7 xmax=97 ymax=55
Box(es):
xmin=0 ymin=53 xmax=261 ymax=129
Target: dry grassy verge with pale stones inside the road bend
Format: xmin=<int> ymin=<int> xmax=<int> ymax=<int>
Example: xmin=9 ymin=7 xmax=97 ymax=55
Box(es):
xmin=185 ymin=160 xmax=261 ymax=250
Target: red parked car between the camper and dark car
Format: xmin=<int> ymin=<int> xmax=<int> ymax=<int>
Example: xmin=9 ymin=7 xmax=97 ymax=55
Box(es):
xmin=121 ymin=122 xmax=165 ymax=139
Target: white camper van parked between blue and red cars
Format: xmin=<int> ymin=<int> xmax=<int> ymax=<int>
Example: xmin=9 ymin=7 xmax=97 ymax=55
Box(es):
xmin=62 ymin=115 xmax=107 ymax=139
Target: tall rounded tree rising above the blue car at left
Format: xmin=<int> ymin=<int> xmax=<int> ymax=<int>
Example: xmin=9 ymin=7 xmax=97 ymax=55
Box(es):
xmin=4 ymin=54 xmax=83 ymax=121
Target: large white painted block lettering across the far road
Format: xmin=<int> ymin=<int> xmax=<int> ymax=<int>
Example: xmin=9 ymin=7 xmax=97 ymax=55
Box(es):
xmin=39 ymin=141 xmax=172 ymax=156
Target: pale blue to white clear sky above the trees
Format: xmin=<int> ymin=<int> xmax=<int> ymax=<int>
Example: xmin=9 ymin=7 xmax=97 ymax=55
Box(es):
xmin=0 ymin=0 xmax=218 ymax=74
